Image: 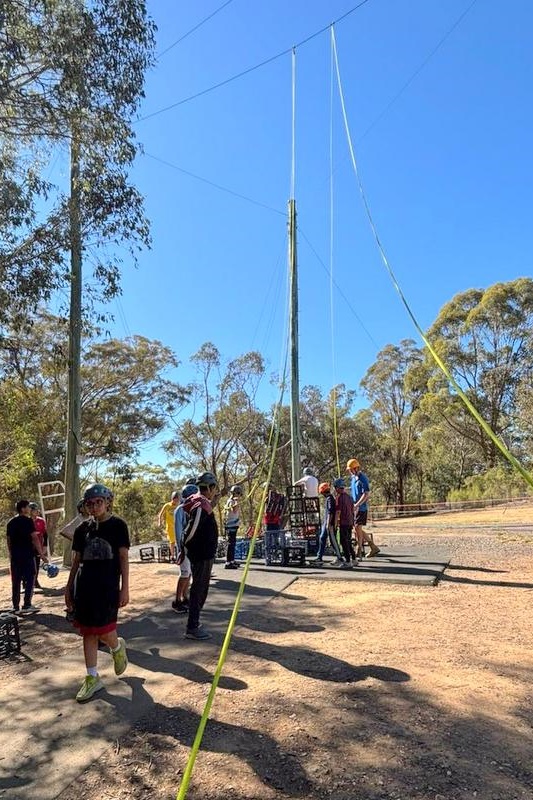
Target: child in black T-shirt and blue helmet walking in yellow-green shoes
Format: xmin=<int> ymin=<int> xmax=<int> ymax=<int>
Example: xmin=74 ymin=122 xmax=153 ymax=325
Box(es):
xmin=65 ymin=483 xmax=130 ymax=703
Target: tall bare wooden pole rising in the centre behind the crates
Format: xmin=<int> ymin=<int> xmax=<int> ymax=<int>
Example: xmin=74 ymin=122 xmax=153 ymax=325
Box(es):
xmin=289 ymin=199 xmax=301 ymax=483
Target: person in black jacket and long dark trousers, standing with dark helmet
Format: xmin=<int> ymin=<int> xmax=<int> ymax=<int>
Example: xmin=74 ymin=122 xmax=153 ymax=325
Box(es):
xmin=178 ymin=472 xmax=218 ymax=639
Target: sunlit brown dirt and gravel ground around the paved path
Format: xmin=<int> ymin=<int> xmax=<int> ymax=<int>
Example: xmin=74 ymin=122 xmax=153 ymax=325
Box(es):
xmin=0 ymin=507 xmax=533 ymax=800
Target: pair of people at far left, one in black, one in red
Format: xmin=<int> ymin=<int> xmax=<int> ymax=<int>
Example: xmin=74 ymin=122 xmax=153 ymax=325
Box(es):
xmin=6 ymin=500 xmax=48 ymax=614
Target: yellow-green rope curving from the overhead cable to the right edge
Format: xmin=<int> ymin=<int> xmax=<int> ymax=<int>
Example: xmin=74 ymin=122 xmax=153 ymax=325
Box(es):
xmin=331 ymin=26 xmax=533 ymax=486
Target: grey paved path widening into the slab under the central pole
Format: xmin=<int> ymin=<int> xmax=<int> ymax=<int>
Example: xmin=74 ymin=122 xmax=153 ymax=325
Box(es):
xmin=0 ymin=547 xmax=448 ymax=800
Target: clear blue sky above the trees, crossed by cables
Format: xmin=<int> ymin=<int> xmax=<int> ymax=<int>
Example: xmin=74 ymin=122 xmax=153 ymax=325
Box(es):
xmin=98 ymin=0 xmax=533 ymax=460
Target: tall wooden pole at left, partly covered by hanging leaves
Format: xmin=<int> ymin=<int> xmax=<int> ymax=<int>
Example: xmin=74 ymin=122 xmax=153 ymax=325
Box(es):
xmin=64 ymin=117 xmax=82 ymax=564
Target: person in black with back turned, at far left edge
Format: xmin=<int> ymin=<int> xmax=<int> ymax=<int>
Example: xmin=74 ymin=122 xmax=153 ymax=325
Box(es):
xmin=6 ymin=500 xmax=48 ymax=614
